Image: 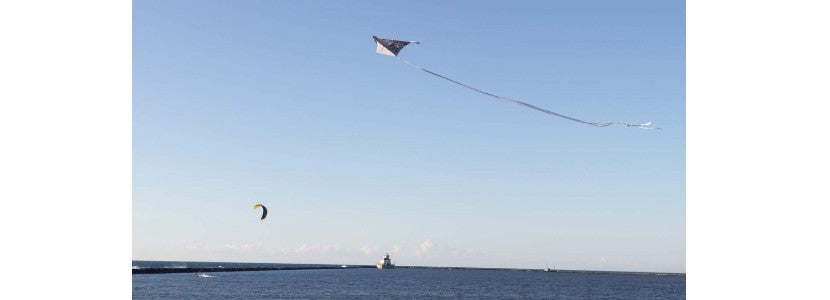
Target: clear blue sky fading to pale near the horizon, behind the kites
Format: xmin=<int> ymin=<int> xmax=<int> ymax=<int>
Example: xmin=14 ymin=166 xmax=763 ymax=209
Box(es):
xmin=132 ymin=1 xmax=686 ymax=272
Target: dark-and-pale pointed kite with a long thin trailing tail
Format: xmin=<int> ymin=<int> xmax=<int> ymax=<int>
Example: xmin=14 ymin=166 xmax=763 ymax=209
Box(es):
xmin=372 ymin=36 xmax=662 ymax=130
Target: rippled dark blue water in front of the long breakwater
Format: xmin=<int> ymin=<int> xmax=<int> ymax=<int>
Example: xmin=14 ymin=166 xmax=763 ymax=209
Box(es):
xmin=133 ymin=263 xmax=686 ymax=299
